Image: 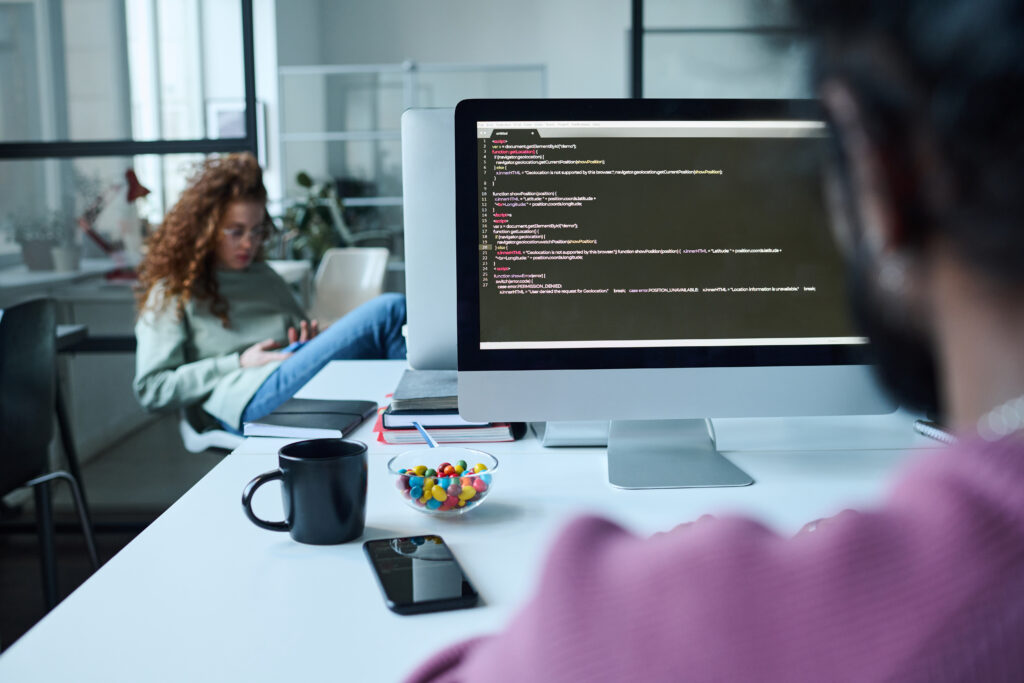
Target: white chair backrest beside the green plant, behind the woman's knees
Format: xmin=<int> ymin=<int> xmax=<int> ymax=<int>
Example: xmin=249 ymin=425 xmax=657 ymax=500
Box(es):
xmin=309 ymin=247 xmax=388 ymax=329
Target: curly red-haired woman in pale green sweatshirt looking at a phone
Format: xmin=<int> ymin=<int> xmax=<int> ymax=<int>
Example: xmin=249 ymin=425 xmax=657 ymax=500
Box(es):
xmin=134 ymin=154 xmax=406 ymax=431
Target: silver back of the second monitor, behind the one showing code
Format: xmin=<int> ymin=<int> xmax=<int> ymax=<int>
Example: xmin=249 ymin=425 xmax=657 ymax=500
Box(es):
xmin=401 ymin=109 xmax=457 ymax=370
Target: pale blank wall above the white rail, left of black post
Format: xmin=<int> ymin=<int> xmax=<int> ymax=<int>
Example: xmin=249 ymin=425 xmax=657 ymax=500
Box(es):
xmin=317 ymin=0 xmax=630 ymax=97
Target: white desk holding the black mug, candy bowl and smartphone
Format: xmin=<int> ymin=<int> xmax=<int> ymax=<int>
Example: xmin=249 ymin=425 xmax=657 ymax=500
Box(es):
xmin=0 ymin=361 xmax=924 ymax=683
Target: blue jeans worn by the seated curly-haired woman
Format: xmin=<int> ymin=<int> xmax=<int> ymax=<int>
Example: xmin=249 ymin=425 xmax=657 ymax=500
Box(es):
xmin=234 ymin=294 xmax=406 ymax=431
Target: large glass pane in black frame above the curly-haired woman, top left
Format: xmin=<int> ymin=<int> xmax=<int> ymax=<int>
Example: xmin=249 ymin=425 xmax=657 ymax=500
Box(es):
xmin=0 ymin=0 xmax=246 ymax=142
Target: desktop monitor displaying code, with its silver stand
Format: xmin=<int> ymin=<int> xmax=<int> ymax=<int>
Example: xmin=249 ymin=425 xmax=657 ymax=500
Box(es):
xmin=455 ymin=99 xmax=895 ymax=487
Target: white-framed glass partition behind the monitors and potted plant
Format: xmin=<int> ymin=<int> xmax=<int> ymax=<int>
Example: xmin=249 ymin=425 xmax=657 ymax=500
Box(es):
xmin=278 ymin=61 xmax=547 ymax=242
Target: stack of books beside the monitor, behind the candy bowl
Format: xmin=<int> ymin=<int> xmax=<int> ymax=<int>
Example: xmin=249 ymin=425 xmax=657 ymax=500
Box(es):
xmin=374 ymin=370 xmax=521 ymax=444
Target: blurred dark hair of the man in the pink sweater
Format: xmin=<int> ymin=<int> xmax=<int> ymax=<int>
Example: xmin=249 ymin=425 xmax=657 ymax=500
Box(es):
xmin=793 ymin=0 xmax=1024 ymax=285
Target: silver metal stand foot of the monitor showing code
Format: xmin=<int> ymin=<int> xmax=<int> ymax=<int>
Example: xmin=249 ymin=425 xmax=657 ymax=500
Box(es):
xmin=608 ymin=420 xmax=754 ymax=488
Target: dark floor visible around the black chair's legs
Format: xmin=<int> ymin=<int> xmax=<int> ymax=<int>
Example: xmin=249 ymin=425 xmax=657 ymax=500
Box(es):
xmin=0 ymin=416 xmax=223 ymax=649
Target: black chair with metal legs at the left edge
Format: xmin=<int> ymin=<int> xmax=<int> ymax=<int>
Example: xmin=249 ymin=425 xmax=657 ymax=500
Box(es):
xmin=0 ymin=299 xmax=99 ymax=608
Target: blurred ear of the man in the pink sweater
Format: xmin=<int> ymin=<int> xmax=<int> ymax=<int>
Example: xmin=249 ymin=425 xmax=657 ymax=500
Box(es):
xmin=820 ymin=80 xmax=908 ymax=259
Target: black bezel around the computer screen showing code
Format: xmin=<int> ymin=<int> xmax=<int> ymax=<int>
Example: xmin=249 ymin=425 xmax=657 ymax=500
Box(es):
xmin=455 ymin=99 xmax=869 ymax=371
